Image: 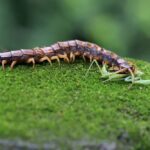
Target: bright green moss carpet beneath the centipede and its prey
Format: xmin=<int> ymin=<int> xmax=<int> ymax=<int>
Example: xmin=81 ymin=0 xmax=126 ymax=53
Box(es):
xmin=0 ymin=60 xmax=150 ymax=148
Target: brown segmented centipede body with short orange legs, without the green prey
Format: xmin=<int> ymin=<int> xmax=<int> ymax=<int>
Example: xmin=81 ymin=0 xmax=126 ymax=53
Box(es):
xmin=0 ymin=40 xmax=134 ymax=73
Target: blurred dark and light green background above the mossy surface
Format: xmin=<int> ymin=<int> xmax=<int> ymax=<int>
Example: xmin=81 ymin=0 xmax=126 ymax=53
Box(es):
xmin=0 ymin=0 xmax=150 ymax=61
